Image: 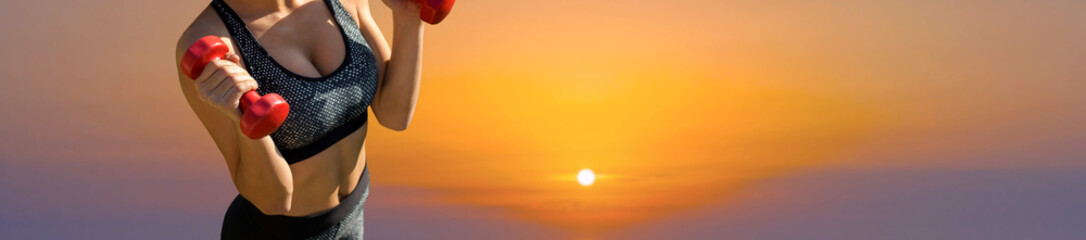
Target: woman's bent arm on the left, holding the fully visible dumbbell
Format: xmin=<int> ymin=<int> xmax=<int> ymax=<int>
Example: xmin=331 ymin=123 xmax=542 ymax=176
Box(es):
xmin=176 ymin=19 xmax=293 ymax=215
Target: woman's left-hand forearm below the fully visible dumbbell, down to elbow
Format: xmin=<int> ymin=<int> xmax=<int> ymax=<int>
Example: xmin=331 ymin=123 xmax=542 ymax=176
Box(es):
xmin=233 ymin=128 xmax=294 ymax=215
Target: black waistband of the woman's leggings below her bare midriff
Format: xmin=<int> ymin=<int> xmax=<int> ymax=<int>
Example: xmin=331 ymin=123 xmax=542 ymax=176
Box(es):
xmin=224 ymin=167 xmax=369 ymax=239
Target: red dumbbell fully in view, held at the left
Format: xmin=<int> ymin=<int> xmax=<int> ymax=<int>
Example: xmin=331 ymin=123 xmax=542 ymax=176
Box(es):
xmin=181 ymin=36 xmax=290 ymax=139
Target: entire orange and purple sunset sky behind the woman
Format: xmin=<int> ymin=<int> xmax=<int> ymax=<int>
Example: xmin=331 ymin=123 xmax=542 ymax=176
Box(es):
xmin=0 ymin=0 xmax=1086 ymax=240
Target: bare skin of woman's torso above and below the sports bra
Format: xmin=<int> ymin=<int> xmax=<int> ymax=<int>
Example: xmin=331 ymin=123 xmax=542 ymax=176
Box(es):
xmin=197 ymin=0 xmax=375 ymax=216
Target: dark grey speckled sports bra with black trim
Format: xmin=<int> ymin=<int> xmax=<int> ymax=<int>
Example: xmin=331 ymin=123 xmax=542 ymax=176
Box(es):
xmin=211 ymin=0 xmax=378 ymax=164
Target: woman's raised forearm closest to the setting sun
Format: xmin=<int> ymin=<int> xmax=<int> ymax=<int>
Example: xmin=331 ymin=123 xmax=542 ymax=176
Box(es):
xmin=374 ymin=14 xmax=424 ymax=130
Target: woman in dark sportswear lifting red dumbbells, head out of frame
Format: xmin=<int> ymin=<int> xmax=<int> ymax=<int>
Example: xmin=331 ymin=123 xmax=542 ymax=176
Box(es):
xmin=176 ymin=0 xmax=422 ymax=239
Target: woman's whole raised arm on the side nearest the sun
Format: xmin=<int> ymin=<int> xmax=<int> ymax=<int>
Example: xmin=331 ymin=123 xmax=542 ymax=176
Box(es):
xmin=358 ymin=0 xmax=424 ymax=130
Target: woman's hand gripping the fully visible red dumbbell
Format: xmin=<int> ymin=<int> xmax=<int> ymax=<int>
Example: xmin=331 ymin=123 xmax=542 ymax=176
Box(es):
xmin=195 ymin=53 xmax=257 ymax=123
